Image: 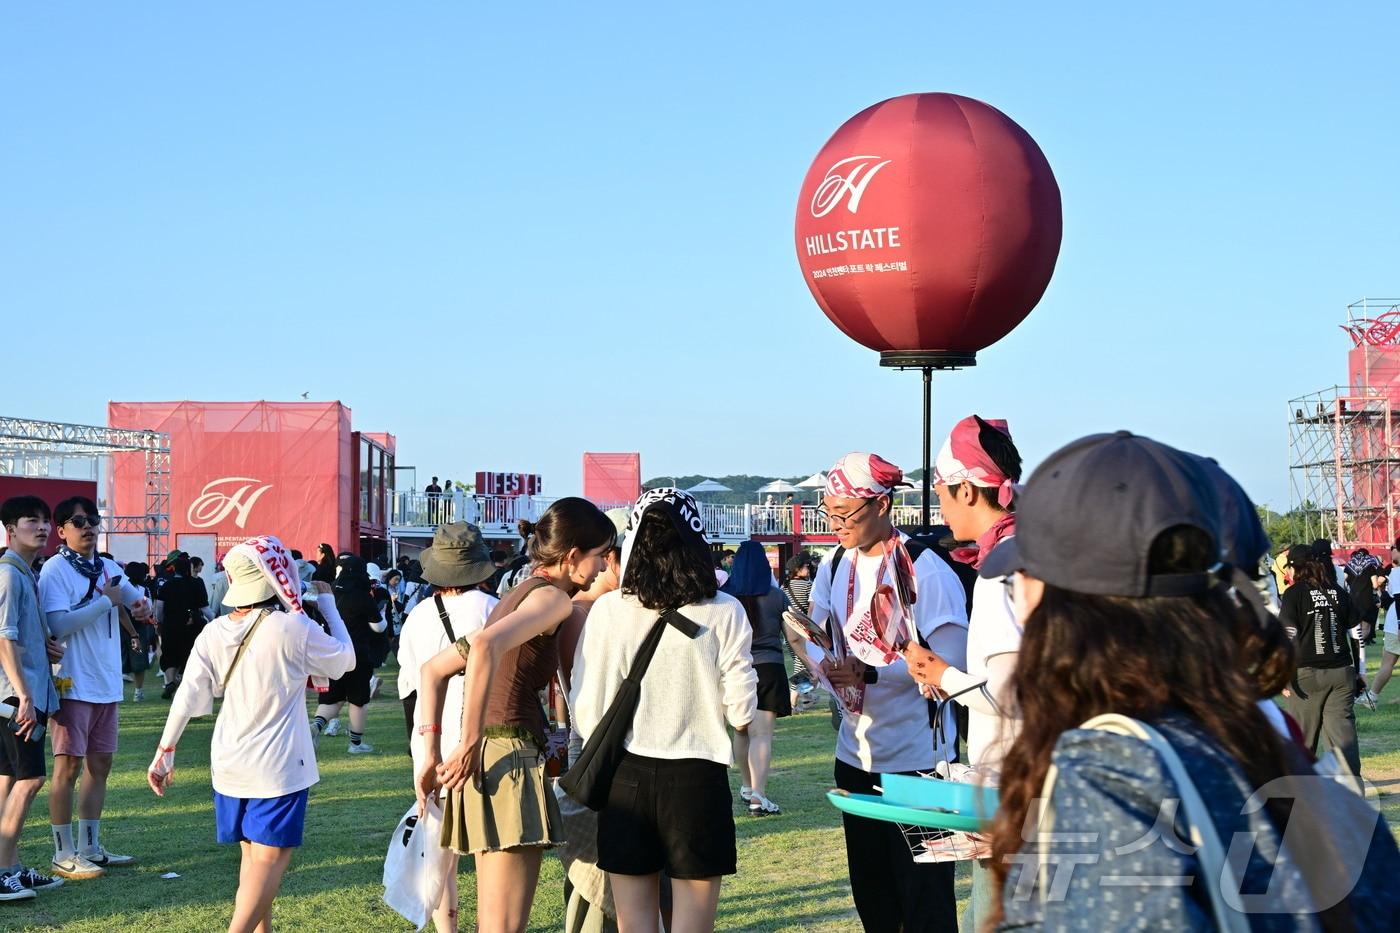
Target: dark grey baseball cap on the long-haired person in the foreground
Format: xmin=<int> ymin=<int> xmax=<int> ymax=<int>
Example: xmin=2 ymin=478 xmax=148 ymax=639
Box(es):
xmin=980 ymin=431 xmax=1221 ymax=597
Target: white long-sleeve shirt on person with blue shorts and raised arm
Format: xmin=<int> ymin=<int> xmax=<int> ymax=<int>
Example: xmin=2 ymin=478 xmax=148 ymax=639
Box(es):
xmin=161 ymin=593 xmax=354 ymax=797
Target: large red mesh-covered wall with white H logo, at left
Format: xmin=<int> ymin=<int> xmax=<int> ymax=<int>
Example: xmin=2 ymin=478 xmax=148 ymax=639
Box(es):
xmin=106 ymin=402 xmax=357 ymax=556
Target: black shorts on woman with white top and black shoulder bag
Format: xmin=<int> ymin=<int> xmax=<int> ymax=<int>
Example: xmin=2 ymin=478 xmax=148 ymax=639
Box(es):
xmin=598 ymin=755 xmax=738 ymax=880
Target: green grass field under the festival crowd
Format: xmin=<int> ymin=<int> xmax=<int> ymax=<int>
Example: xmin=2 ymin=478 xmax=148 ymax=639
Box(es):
xmin=8 ymin=652 xmax=1400 ymax=933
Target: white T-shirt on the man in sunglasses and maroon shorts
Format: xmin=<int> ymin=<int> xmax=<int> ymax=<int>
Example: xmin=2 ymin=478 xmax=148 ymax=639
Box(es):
xmin=39 ymin=555 xmax=146 ymax=703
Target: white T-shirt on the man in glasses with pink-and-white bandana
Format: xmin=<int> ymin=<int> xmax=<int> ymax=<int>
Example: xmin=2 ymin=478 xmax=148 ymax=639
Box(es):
xmin=809 ymin=532 xmax=967 ymax=773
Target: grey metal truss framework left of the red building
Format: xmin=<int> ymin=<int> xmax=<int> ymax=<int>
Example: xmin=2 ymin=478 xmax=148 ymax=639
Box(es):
xmin=0 ymin=416 xmax=171 ymax=566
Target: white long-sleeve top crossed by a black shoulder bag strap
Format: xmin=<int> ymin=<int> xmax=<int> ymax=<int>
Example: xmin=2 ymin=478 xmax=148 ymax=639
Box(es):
xmin=568 ymin=593 xmax=759 ymax=765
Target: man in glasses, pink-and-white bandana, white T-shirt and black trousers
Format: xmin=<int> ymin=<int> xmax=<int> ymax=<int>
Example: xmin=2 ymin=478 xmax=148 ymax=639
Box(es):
xmin=811 ymin=452 xmax=967 ymax=933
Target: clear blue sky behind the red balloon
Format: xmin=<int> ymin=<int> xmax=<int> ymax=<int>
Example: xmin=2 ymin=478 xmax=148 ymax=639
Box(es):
xmin=0 ymin=1 xmax=1400 ymax=506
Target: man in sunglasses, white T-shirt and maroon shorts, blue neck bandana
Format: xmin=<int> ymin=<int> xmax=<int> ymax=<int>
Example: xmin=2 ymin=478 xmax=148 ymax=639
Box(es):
xmin=39 ymin=496 xmax=151 ymax=878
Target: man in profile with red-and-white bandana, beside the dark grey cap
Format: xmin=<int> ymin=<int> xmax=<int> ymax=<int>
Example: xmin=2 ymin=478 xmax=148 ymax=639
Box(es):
xmin=904 ymin=415 xmax=1021 ymax=930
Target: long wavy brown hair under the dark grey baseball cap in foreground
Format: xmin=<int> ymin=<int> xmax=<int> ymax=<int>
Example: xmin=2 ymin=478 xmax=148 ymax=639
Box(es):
xmin=990 ymin=527 xmax=1294 ymax=925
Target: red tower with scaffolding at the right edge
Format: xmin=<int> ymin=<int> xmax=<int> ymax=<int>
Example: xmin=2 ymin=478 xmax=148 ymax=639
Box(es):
xmin=1275 ymin=298 xmax=1400 ymax=555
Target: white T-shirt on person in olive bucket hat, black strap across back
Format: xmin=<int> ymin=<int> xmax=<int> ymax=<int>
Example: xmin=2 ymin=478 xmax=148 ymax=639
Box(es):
xmin=399 ymin=590 xmax=500 ymax=773
